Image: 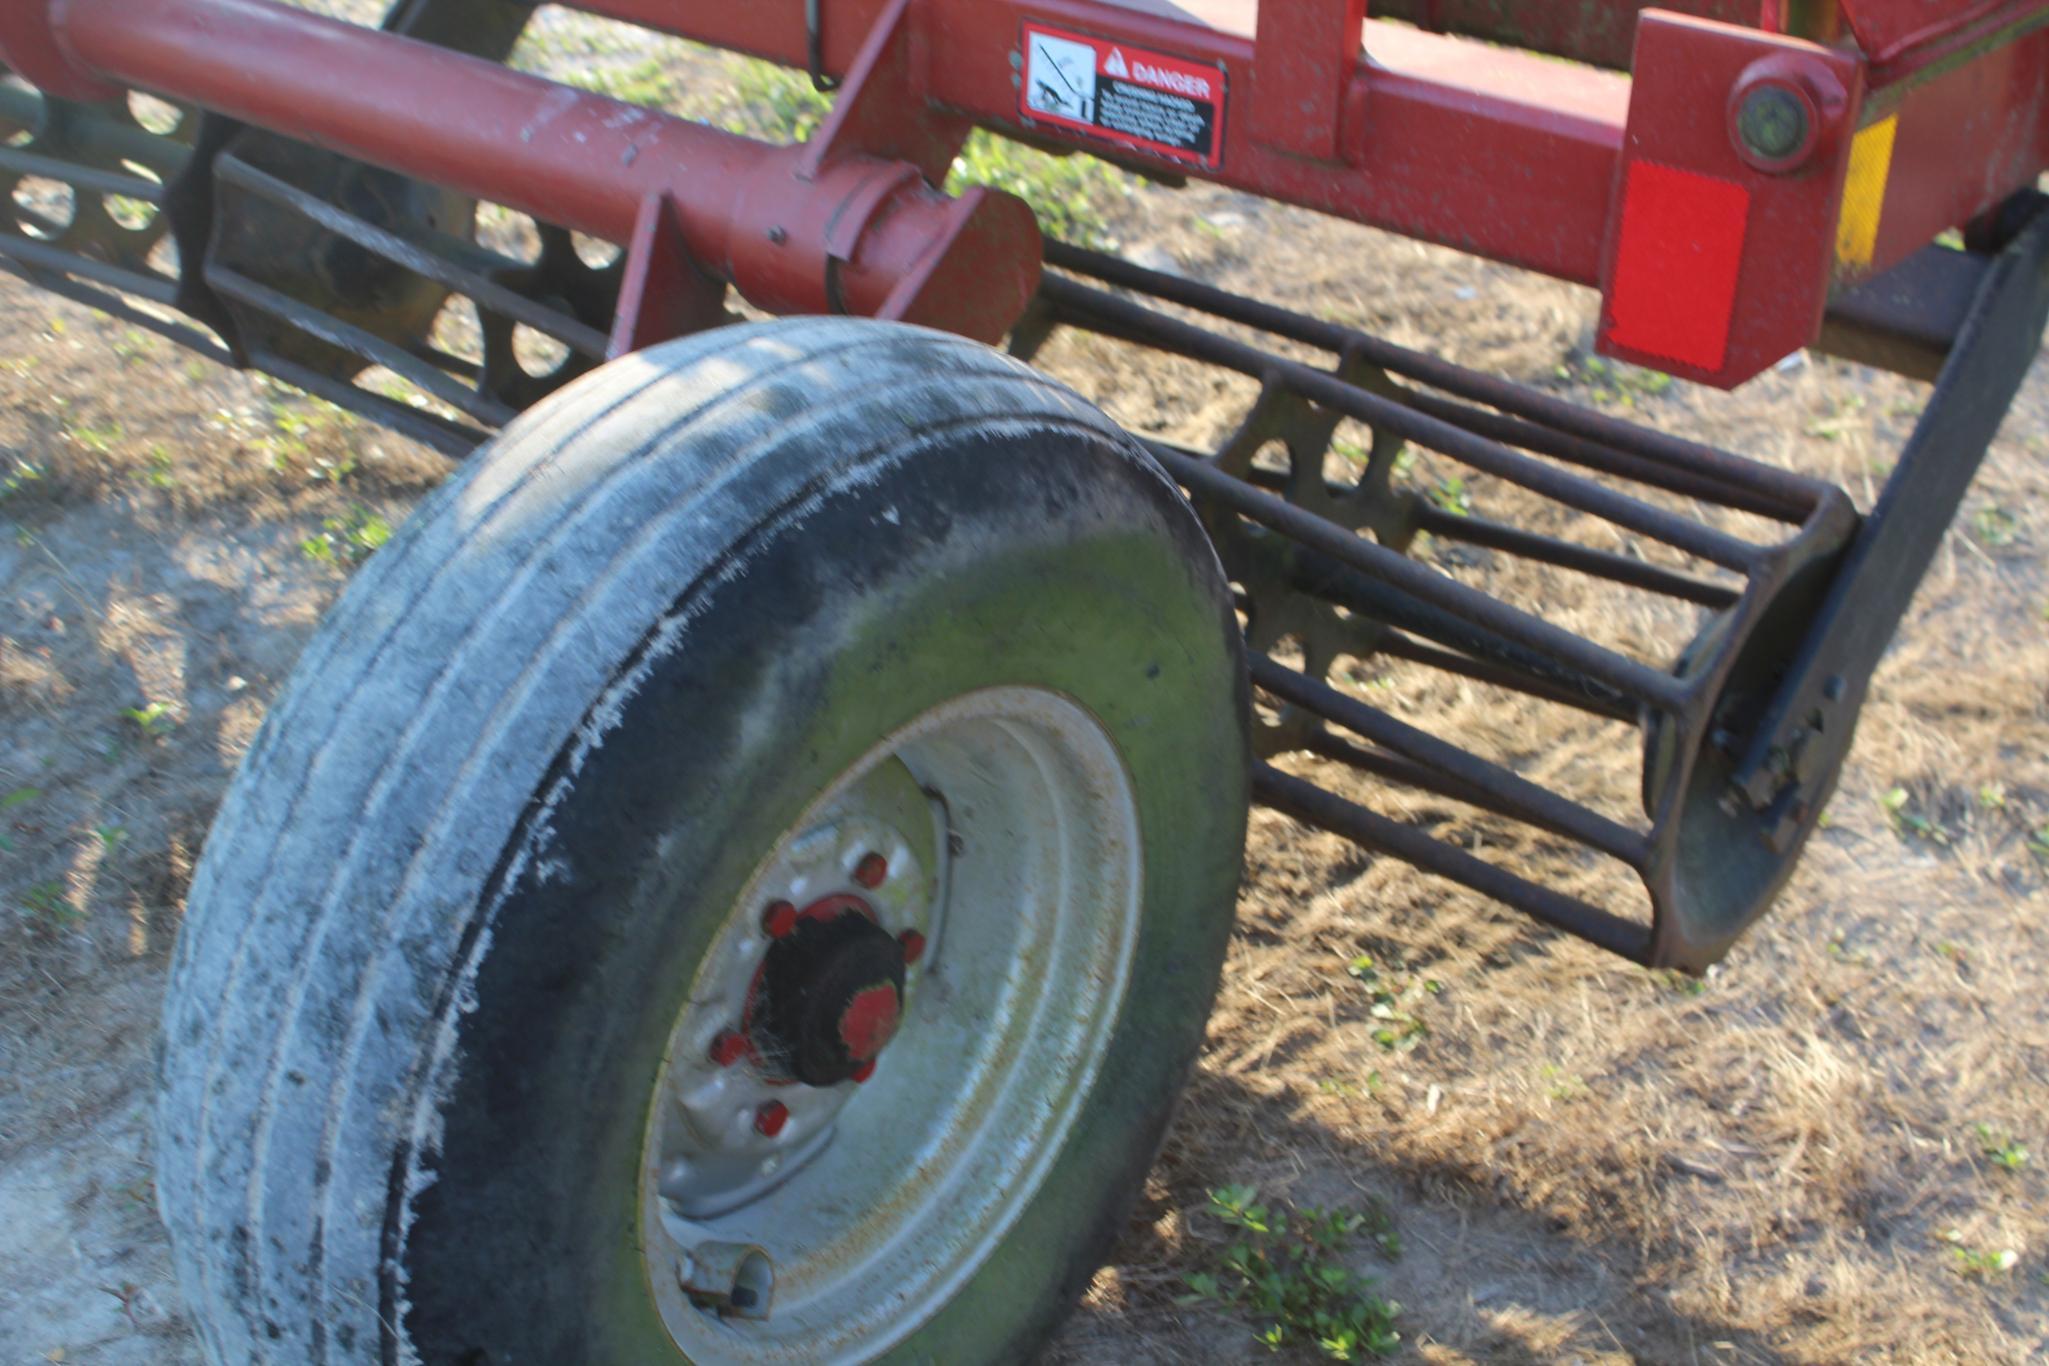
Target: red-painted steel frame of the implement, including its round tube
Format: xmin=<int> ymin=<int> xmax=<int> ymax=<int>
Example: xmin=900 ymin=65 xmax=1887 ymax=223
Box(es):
xmin=0 ymin=0 xmax=2049 ymax=387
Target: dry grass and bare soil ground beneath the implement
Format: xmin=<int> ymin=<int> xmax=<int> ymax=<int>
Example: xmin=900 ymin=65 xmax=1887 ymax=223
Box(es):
xmin=0 ymin=13 xmax=2049 ymax=1364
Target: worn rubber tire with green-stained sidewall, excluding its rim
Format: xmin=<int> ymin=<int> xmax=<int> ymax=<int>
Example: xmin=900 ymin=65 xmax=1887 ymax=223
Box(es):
xmin=158 ymin=319 xmax=1250 ymax=1362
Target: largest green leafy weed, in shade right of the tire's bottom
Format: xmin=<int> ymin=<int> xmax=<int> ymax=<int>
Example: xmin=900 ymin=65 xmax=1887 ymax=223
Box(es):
xmin=1182 ymin=1186 xmax=1402 ymax=1362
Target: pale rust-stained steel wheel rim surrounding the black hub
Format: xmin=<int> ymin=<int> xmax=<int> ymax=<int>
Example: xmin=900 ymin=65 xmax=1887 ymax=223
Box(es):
xmin=639 ymin=688 xmax=1141 ymax=1362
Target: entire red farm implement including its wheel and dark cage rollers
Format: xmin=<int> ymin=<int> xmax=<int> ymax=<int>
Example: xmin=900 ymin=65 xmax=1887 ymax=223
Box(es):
xmin=0 ymin=0 xmax=2049 ymax=1362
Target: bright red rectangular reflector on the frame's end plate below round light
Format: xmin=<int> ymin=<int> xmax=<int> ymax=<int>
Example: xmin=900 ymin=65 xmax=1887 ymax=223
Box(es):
xmin=1608 ymin=162 xmax=1750 ymax=371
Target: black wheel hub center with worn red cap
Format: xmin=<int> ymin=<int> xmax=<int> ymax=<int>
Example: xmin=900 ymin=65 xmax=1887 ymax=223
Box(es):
xmin=746 ymin=897 xmax=904 ymax=1085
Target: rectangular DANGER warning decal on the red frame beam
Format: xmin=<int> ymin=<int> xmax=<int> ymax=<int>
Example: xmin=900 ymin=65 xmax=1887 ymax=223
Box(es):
xmin=1018 ymin=25 xmax=1223 ymax=168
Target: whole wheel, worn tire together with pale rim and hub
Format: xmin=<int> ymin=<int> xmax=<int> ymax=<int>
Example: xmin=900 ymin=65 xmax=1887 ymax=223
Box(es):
xmin=158 ymin=319 xmax=1250 ymax=1364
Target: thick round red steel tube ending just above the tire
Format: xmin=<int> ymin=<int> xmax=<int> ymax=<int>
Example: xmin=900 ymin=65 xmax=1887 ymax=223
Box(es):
xmin=51 ymin=0 xmax=1039 ymax=340
